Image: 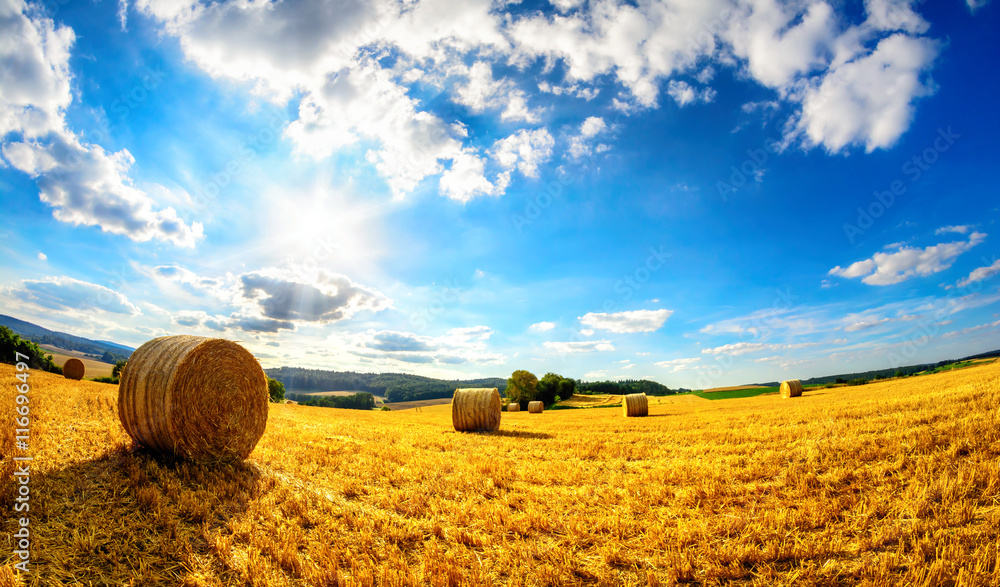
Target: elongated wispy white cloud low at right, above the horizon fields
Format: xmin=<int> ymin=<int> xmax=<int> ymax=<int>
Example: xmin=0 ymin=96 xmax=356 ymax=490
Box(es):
xmin=829 ymin=232 xmax=986 ymax=285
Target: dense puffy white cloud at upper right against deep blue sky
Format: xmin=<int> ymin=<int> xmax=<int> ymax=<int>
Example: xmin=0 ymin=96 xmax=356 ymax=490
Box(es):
xmin=795 ymin=33 xmax=938 ymax=152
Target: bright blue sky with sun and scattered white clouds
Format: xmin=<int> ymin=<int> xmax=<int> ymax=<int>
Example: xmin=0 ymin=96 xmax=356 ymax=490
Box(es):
xmin=0 ymin=0 xmax=1000 ymax=388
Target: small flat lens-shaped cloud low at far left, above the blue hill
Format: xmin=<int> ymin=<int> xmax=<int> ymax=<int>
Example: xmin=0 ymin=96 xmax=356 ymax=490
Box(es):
xmin=7 ymin=277 xmax=141 ymax=316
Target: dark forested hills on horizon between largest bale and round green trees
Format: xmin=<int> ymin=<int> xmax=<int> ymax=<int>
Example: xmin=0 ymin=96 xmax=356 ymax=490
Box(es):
xmin=265 ymin=367 xmax=507 ymax=402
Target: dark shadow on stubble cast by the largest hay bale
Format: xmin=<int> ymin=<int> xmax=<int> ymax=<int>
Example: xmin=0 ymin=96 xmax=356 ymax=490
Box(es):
xmin=23 ymin=448 xmax=270 ymax=585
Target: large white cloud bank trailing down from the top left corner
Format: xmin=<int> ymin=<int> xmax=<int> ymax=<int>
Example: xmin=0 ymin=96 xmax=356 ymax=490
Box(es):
xmin=0 ymin=1 xmax=203 ymax=247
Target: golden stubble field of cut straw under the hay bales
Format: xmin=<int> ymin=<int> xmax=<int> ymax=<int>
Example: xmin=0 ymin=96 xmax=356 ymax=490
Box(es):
xmin=0 ymin=363 xmax=1000 ymax=587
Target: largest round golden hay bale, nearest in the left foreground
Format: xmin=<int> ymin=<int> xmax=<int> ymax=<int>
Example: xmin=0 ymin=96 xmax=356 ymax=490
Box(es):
xmin=118 ymin=336 xmax=269 ymax=460
